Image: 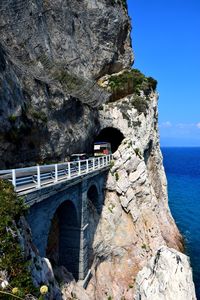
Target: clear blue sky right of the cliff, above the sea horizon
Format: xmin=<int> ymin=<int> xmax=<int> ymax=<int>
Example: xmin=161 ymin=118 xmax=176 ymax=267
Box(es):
xmin=128 ymin=0 xmax=200 ymax=147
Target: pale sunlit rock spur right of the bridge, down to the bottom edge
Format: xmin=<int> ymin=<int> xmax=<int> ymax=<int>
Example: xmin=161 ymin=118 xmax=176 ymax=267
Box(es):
xmin=87 ymin=92 xmax=195 ymax=300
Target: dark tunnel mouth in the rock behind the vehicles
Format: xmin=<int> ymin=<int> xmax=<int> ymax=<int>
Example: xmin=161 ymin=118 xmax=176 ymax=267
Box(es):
xmin=95 ymin=127 xmax=124 ymax=153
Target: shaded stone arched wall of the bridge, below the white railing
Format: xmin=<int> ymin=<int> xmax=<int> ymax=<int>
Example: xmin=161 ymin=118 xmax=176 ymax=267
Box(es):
xmin=26 ymin=170 xmax=107 ymax=280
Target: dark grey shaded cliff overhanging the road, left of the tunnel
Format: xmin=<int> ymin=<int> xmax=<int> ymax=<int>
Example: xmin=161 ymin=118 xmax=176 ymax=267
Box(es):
xmin=0 ymin=0 xmax=133 ymax=168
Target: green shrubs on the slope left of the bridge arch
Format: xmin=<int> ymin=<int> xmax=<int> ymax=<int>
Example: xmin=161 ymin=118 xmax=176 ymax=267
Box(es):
xmin=0 ymin=179 xmax=36 ymax=299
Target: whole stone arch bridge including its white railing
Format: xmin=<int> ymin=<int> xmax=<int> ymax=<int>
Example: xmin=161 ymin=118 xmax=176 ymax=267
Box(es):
xmin=0 ymin=155 xmax=112 ymax=280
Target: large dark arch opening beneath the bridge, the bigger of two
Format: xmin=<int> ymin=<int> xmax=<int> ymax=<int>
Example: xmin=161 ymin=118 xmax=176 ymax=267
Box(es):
xmin=46 ymin=200 xmax=80 ymax=279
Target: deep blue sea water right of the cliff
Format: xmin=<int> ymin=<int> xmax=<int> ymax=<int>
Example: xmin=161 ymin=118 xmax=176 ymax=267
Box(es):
xmin=161 ymin=148 xmax=200 ymax=300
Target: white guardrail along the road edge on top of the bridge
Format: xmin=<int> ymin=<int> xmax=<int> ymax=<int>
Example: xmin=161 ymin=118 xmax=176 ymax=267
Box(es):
xmin=0 ymin=155 xmax=112 ymax=193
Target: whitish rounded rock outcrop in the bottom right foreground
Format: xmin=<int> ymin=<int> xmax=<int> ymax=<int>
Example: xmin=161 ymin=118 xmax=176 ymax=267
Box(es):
xmin=134 ymin=246 xmax=196 ymax=300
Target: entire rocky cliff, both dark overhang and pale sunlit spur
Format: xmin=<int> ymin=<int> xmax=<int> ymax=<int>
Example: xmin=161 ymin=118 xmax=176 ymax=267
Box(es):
xmin=0 ymin=0 xmax=195 ymax=300
